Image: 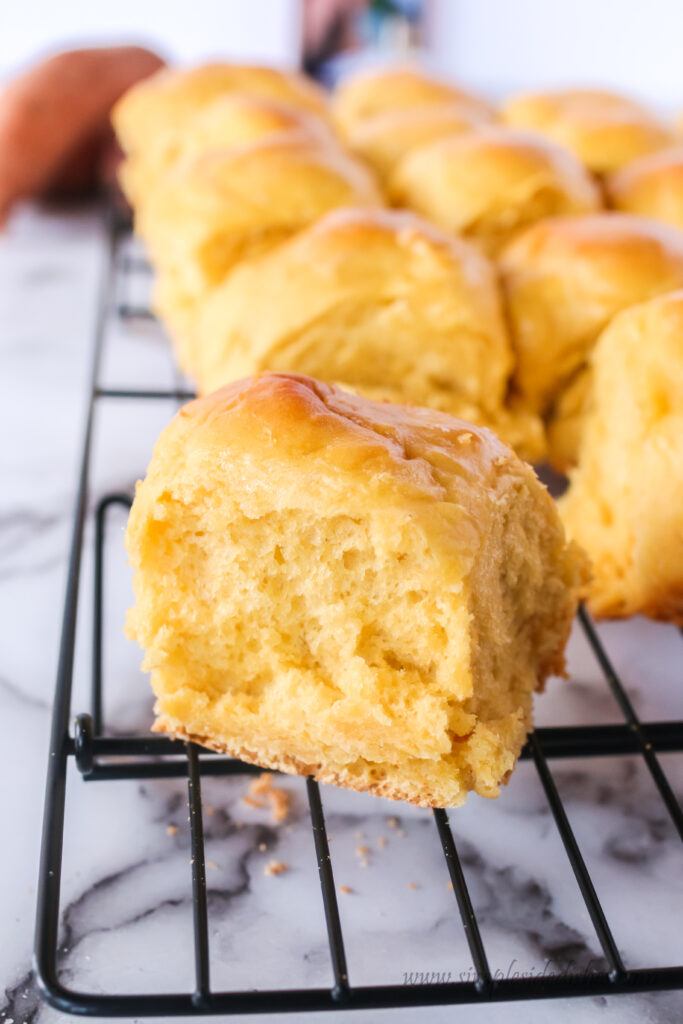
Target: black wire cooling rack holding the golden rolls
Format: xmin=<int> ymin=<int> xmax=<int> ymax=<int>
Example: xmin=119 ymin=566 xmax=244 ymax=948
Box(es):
xmin=35 ymin=205 xmax=683 ymax=1019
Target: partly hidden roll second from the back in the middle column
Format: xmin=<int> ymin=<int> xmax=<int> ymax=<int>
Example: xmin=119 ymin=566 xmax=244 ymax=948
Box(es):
xmin=346 ymin=102 xmax=492 ymax=181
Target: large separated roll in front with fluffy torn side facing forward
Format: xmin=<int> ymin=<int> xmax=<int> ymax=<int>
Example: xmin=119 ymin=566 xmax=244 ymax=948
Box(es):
xmin=126 ymin=374 xmax=583 ymax=806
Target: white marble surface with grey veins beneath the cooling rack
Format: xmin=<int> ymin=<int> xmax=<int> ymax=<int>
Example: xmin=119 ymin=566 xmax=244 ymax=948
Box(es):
xmin=0 ymin=201 xmax=683 ymax=1024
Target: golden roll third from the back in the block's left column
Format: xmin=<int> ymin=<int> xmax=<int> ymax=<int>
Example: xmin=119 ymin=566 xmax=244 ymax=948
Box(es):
xmin=135 ymin=138 xmax=381 ymax=370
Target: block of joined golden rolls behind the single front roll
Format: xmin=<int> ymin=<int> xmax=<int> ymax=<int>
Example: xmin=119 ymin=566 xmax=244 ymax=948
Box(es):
xmin=114 ymin=63 xmax=683 ymax=623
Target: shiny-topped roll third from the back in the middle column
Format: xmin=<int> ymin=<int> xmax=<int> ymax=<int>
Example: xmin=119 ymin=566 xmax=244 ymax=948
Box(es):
xmin=388 ymin=126 xmax=600 ymax=256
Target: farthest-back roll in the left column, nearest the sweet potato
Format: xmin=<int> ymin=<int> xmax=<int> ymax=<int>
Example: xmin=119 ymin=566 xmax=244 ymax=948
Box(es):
xmin=112 ymin=63 xmax=327 ymax=154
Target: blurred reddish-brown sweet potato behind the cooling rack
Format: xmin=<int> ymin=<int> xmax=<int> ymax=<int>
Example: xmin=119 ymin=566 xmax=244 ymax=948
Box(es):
xmin=0 ymin=46 xmax=164 ymax=223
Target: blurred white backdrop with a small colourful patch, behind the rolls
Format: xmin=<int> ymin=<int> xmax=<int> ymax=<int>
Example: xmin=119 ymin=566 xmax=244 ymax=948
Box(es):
xmin=0 ymin=0 xmax=683 ymax=105
